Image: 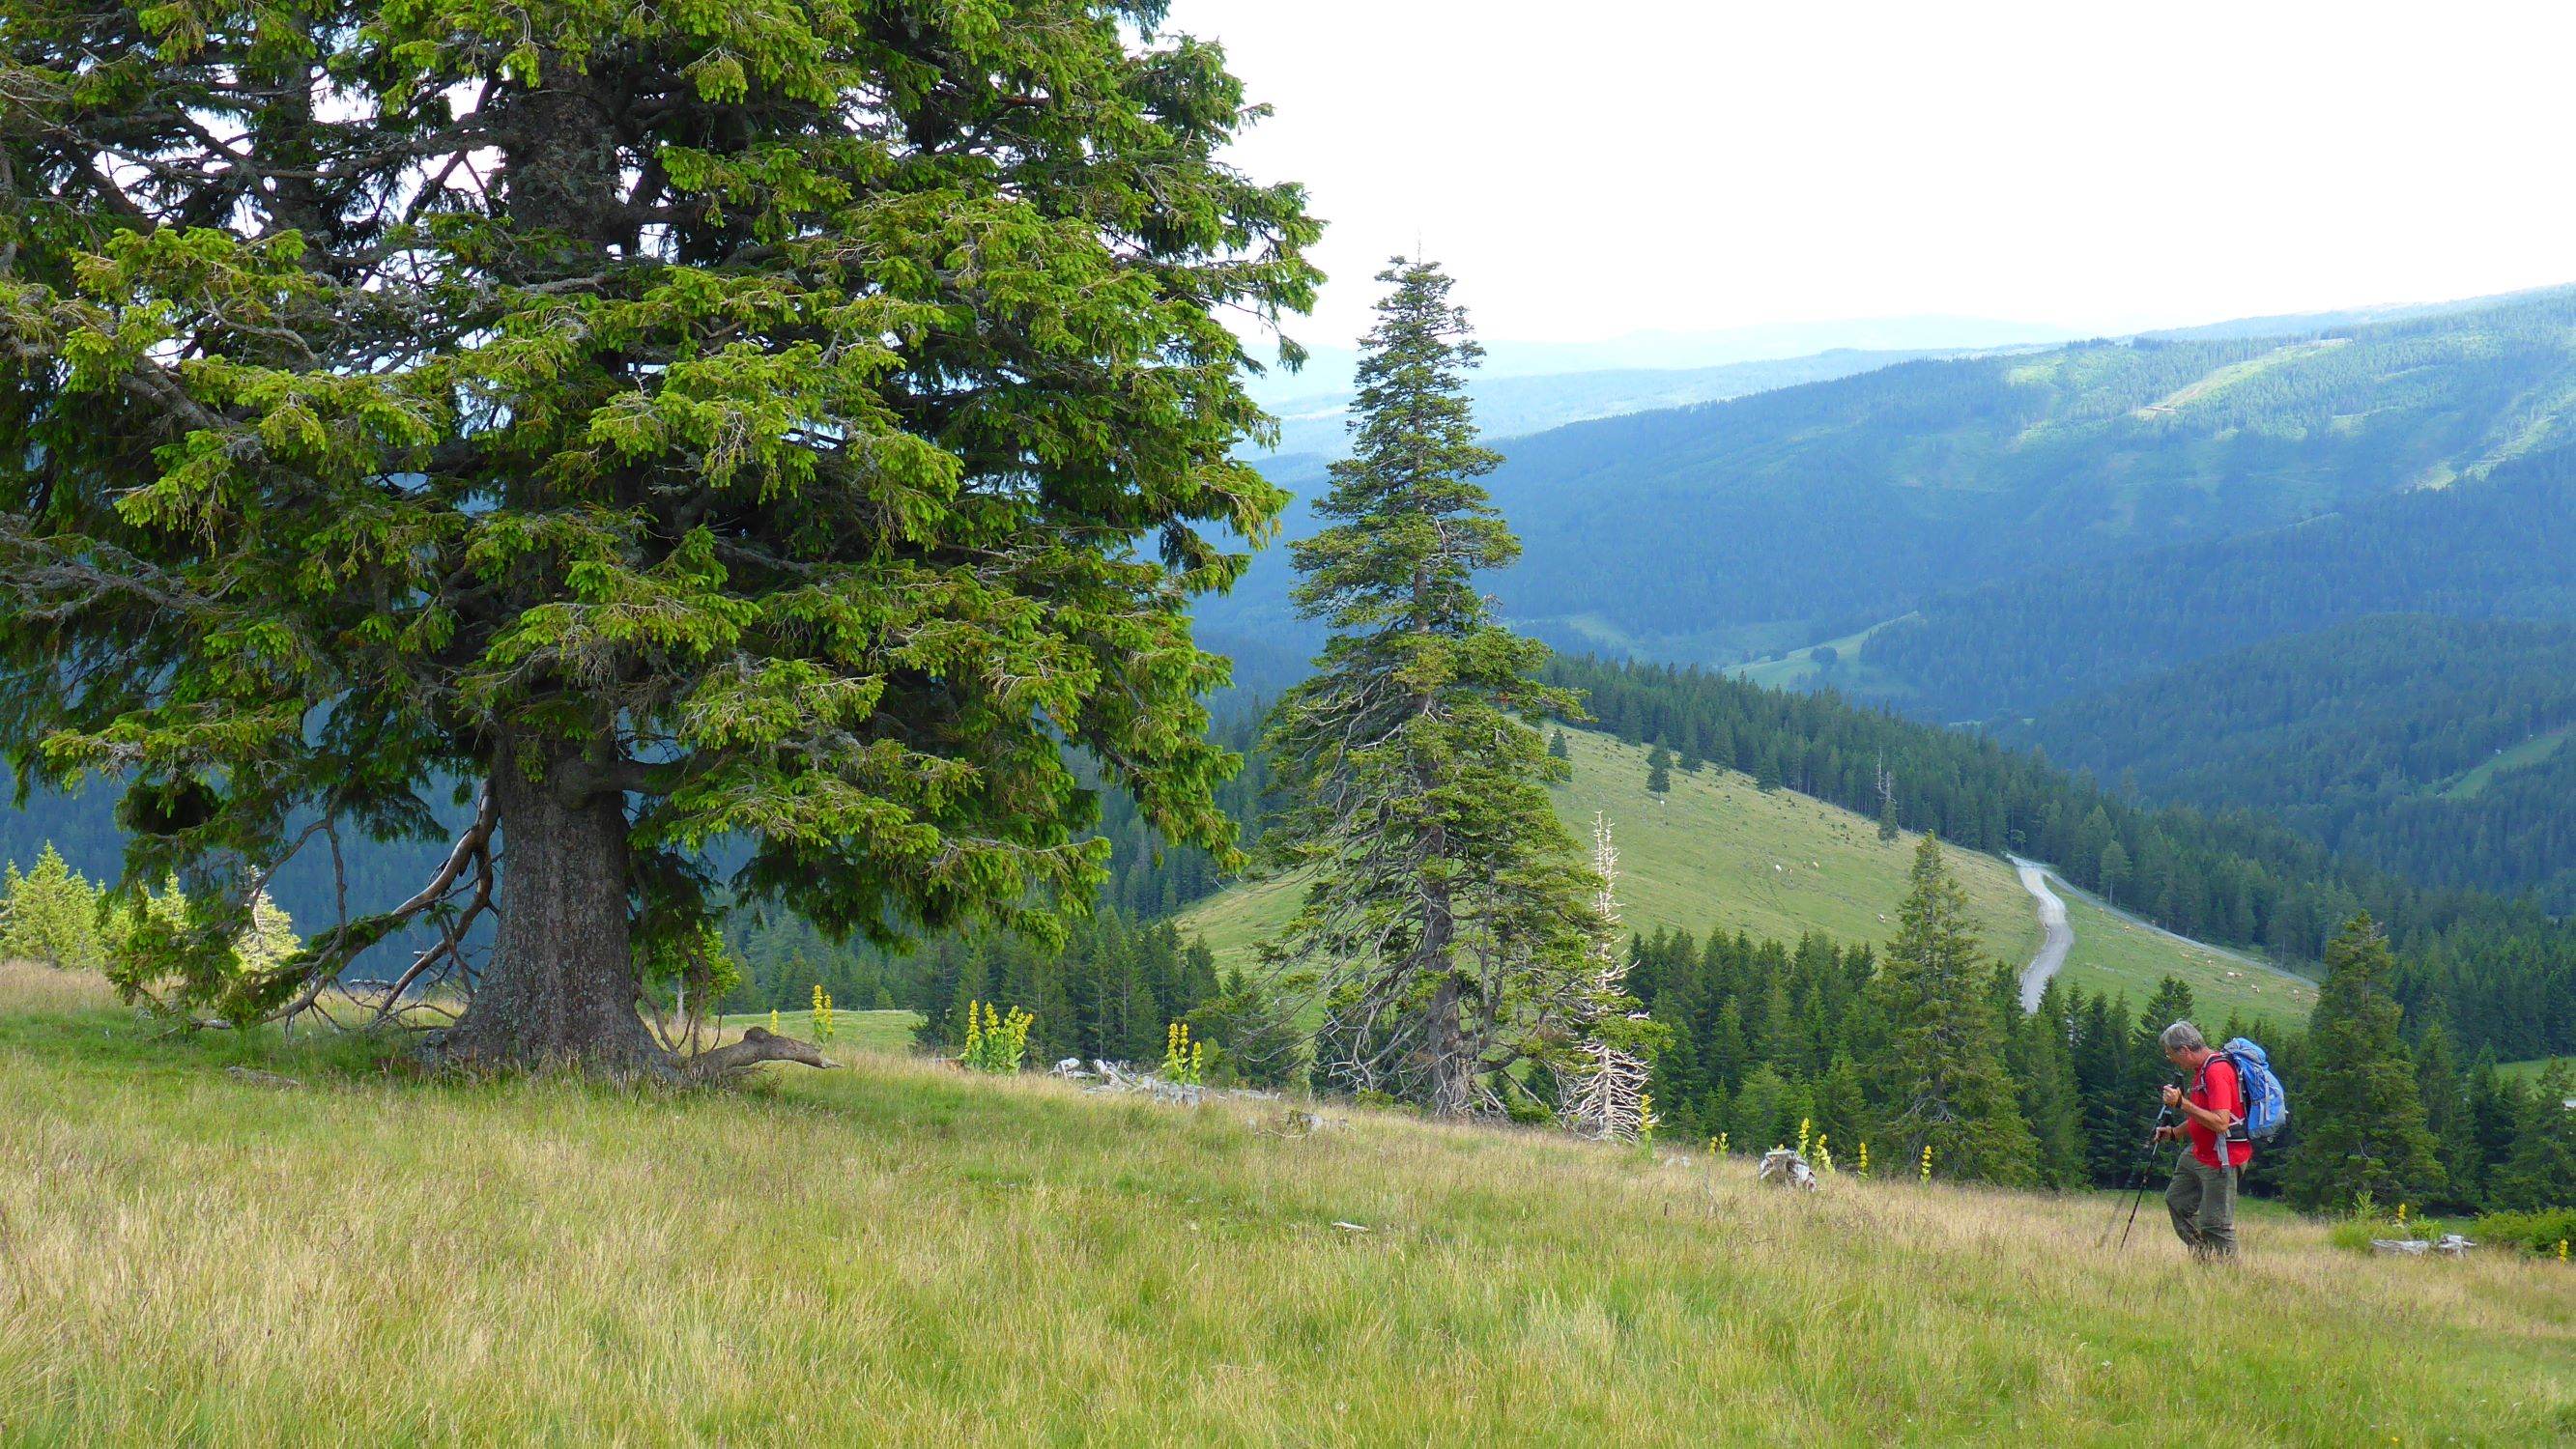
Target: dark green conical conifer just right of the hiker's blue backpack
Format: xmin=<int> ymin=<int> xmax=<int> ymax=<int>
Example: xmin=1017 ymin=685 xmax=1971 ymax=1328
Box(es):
xmin=2285 ymin=916 xmax=2445 ymax=1209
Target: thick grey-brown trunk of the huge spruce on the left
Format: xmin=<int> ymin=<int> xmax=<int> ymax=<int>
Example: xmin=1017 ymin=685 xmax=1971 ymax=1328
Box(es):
xmin=448 ymin=752 xmax=670 ymax=1076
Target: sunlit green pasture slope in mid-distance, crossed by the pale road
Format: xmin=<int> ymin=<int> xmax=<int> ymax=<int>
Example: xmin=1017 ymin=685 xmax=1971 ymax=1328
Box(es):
xmin=1180 ymin=731 xmax=2316 ymax=1022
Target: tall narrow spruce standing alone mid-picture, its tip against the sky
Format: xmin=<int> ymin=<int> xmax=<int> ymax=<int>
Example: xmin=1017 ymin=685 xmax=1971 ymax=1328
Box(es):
xmin=1262 ymin=257 xmax=1597 ymax=1115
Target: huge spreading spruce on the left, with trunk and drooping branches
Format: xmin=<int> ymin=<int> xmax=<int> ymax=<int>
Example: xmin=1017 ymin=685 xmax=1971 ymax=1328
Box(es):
xmin=0 ymin=0 xmax=1316 ymax=1070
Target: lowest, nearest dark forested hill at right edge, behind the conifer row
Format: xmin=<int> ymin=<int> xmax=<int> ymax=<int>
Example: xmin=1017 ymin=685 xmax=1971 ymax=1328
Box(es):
xmin=1999 ymin=615 xmax=2576 ymax=914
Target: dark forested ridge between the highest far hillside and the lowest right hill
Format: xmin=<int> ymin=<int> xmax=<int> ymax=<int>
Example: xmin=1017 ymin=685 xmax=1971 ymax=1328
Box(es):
xmin=1868 ymin=448 xmax=2576 ymax=721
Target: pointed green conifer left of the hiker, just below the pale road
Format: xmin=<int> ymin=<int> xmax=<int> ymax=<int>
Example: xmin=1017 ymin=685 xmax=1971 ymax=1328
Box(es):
xmin=1873 ymin=837 xmax=2040 ymax=1184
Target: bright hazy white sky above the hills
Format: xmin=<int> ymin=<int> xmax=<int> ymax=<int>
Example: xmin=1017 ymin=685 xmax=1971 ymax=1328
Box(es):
xmin=1172 ymin=0 xmax=2576 ymax=342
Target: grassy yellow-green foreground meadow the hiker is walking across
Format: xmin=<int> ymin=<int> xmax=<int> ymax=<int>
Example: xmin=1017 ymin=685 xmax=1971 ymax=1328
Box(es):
xmin=0 ymin=968 xmax=2576 ymax=1449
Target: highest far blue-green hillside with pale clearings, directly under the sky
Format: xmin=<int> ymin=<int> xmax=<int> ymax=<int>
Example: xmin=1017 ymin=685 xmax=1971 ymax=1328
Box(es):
xmin=1492 ymin=291 xmax=2576 ymax=662
